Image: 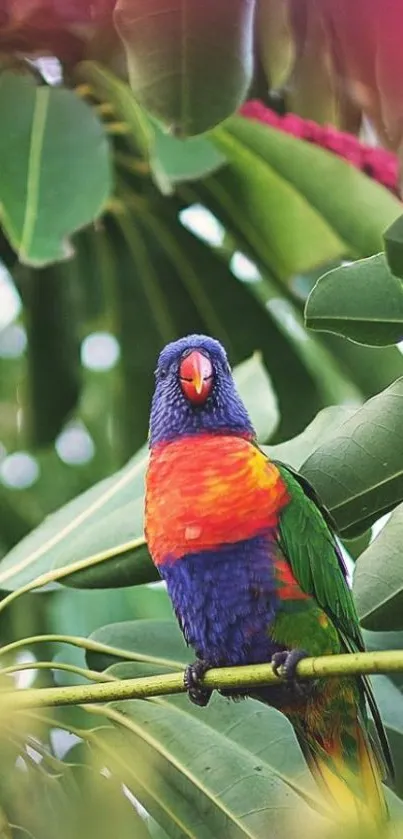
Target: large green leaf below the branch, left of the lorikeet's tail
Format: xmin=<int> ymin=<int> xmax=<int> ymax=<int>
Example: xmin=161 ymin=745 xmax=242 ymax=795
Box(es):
xmin=108 ymin=699 xmax=320 ymax=839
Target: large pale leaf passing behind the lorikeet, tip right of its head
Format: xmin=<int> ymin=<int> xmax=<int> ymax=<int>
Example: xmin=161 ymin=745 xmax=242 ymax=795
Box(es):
xmin=0 ymin=357 xmax=278 ymax=590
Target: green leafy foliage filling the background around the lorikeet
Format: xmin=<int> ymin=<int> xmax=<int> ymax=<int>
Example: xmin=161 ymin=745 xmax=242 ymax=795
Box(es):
xmin=0 ymin=0 xmax=403 ymax=839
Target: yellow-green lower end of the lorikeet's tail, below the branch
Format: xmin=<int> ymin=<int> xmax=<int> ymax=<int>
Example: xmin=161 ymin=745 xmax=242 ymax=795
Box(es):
xmin=299 ymin=720 xmax=389 ymax=827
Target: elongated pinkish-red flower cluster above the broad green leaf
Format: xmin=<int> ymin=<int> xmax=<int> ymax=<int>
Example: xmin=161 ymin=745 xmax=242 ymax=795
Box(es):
xmin=241 ymin=99 xmax=399 ymax=194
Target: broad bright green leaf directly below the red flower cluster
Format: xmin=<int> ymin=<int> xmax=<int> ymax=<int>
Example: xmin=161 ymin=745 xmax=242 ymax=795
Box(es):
xmin=212 ymin=117 xmax=401 ymax=270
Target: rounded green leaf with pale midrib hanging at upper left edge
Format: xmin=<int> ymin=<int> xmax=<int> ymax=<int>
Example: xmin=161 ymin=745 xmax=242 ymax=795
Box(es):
xmin=0 ymin=72 xmax=111 ymax=266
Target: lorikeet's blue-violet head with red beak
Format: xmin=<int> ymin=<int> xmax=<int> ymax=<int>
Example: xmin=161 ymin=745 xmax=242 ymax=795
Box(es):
xmin=150 ymin=335 xmax=254 ymax=446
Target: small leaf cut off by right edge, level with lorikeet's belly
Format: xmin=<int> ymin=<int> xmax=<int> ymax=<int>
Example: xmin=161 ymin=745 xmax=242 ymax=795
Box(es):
xmin=354 ymin=504 xmax=403 ymax=631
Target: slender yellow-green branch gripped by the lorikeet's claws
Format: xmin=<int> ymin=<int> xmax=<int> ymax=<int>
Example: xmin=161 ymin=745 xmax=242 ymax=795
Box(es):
xmin=0 ymin=650 xmax=403 ymax=710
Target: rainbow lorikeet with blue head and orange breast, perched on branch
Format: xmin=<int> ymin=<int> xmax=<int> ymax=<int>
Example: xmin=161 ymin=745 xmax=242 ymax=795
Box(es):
xmin=146 ymin=335 xmax=393 ymax=821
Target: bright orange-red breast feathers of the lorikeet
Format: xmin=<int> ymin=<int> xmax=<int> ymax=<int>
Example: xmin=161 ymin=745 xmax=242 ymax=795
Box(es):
xmin=145 ymin=434 xmax=288 ymax=565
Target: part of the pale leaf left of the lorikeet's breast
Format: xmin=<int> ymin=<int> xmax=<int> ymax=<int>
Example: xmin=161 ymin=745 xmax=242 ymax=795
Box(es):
xmin=0 ymin=450 xmax=150 ymax=590
